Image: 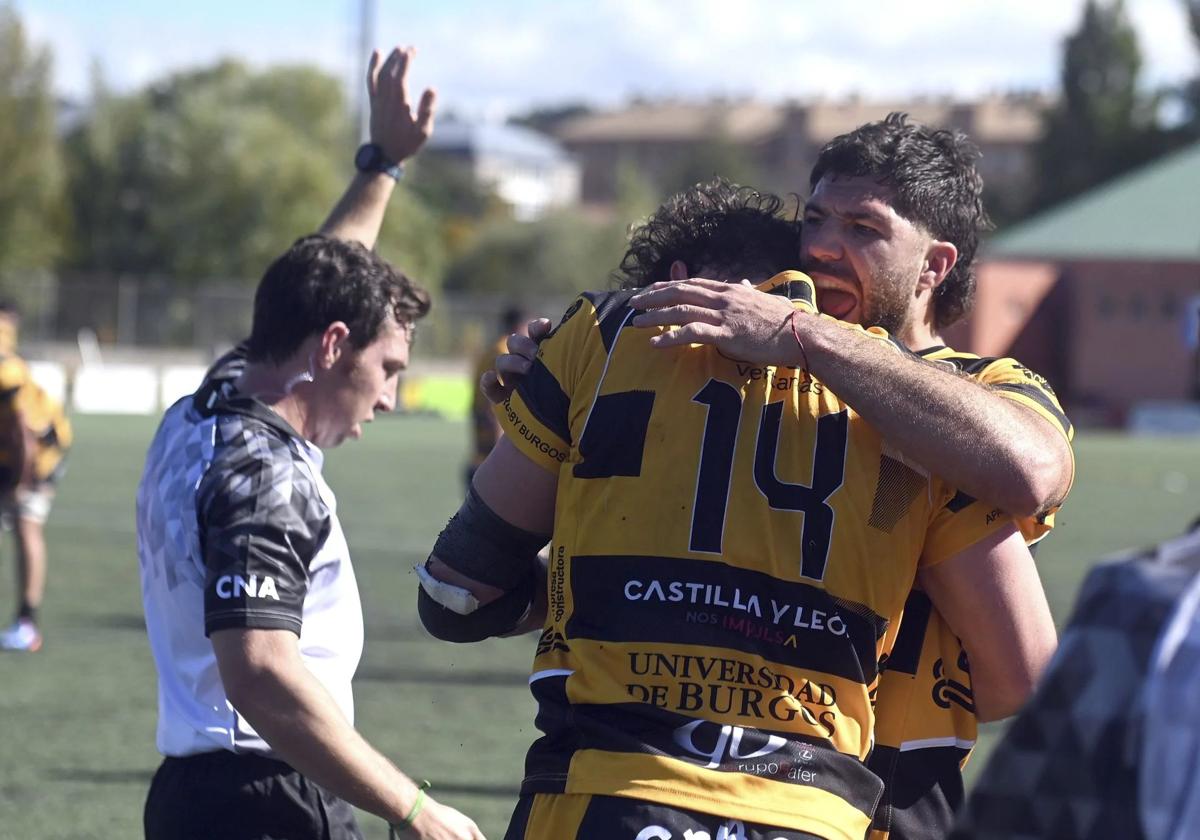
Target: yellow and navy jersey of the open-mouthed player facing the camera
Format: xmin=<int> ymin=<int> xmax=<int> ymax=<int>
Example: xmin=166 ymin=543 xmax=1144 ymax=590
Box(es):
xmin=868 ymin=347 xmax=1074 ymax=840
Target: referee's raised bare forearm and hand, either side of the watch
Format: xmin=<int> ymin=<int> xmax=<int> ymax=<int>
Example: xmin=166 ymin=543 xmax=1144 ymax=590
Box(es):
xmin=320 ymin=47 xmax=437 ymax=248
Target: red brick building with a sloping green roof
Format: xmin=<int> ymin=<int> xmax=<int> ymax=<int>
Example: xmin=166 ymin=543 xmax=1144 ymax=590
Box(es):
xmin=948 ymin=144 xmax=1200 ymax=425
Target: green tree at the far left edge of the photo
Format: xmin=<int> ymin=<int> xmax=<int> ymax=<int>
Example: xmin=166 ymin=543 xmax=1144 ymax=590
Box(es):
xmin=0 ymin=5 xmax=65 ymax=272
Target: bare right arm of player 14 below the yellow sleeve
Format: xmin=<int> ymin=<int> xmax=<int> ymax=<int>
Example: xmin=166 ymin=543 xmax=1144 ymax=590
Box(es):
xmin=918 ymin=527 xmax=1057 ymax=722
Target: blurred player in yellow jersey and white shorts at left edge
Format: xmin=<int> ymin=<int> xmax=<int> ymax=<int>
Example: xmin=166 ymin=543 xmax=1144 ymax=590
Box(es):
xmin=0 ymin=301 xmax=71 ymax=653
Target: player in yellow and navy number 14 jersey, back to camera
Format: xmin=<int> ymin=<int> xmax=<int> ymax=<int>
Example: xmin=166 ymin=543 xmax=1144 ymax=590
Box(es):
xmin=418 ymin=182 xmax=1054 ymax=840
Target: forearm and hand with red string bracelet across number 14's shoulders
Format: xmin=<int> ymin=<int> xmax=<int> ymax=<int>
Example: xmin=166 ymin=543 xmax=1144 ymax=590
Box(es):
xmin=630 ymin=275 xmax=1073 ymax=517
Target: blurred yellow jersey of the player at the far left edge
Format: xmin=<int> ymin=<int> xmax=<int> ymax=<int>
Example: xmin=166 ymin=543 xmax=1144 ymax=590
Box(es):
xmin=0 ymin=355 xmax=71 ymax=485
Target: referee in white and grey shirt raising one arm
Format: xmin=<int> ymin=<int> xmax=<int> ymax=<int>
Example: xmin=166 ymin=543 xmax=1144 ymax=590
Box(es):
xmin=137 ymin=48 xmax=482 ymax=840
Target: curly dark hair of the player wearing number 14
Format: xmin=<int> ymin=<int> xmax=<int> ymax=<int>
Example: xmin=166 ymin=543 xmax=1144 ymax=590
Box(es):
xmin=613 ymin=178 xmax=799 ymax=289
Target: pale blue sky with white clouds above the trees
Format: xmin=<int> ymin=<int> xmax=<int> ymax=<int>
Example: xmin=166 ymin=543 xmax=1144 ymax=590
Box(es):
xmin=14 ymin=0 xmax=1198 ymax=116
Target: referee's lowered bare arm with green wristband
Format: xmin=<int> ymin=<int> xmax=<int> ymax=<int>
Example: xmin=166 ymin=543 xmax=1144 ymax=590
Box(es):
xmin=212 ymin=629 xmax=484 ymax=840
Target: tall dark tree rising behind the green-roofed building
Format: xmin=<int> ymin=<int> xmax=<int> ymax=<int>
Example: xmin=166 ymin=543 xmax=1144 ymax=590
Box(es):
xmin=1034 ymin=0 xmax=1164 ymax=208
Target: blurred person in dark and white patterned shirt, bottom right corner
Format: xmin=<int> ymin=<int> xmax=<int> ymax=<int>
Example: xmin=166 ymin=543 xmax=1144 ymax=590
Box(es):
xmin=952 ymin=523 xmax=1200 ymax=840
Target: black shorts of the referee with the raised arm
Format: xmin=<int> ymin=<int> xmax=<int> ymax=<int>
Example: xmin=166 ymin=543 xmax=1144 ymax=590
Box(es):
xmin=143 ymin=750 xmax=362 ymax=840
